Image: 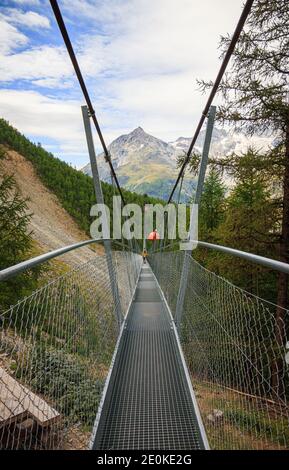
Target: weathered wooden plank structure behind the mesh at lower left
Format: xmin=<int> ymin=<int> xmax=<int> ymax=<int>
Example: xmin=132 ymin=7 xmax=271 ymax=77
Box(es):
xmin=0 ymin=367 xmax=60 ymax=427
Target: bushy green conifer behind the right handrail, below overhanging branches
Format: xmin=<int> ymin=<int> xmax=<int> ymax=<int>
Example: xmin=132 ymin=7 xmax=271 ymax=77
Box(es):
xmin=215 ymin=149 xmax=280 ymax=301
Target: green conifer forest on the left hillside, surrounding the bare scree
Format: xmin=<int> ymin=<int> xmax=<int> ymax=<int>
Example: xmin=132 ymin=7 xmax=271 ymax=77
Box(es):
xmin=0 ymin=119 xmax=160 ymax=311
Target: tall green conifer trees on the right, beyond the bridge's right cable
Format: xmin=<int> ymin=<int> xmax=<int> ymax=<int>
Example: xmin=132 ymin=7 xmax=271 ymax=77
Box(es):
xmin=176 ymin=0 xmax=289 ymax=314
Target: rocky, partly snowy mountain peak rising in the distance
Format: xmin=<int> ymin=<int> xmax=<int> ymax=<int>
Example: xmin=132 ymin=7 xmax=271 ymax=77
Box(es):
xmin=82 ymin=127 xmax=272 ymax=198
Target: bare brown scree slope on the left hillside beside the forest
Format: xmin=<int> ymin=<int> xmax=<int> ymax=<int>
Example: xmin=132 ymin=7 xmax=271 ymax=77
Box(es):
xmin=3 ymin=150 xmax=102 ymax=266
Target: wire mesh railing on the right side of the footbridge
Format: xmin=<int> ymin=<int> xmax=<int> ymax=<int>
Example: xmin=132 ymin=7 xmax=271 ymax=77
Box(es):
xmin=150 ymin=252 xmax=289 ymax=449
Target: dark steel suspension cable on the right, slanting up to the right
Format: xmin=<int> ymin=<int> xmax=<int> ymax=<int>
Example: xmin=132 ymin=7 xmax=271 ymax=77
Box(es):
xmin=168 ymin=0 xmax=254 ymax=203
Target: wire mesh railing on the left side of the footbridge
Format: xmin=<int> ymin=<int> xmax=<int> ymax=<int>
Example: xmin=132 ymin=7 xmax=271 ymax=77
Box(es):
xmin=0 ymin=251 xmax=141 ymax=449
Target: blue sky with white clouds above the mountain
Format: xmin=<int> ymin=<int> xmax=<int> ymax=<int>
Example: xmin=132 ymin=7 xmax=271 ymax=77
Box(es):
xmin=0 ymin=0 xmax=243 ymax=167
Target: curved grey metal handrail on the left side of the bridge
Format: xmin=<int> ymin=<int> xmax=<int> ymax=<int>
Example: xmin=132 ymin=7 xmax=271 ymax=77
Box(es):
xmin=0 ymin=238 xmax=109 ymax=282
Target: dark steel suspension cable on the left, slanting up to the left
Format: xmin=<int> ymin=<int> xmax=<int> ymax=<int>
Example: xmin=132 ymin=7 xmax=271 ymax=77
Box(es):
xmin=50 ymin=0 xmax=125 ymax=204
